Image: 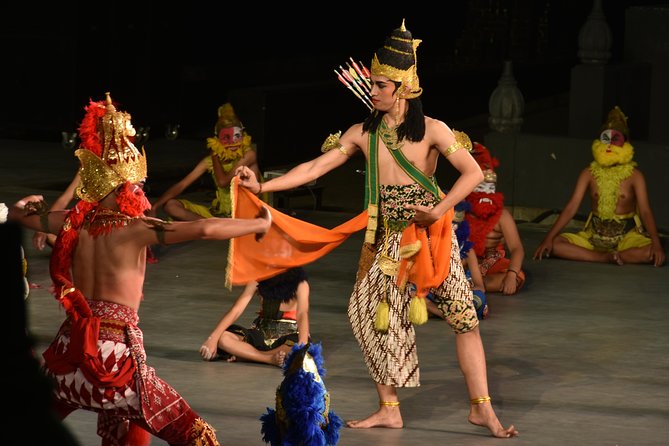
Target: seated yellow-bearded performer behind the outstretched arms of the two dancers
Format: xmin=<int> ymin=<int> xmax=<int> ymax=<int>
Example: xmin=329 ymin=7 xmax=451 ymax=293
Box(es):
xmin=148 ymin=103 xmax=260 ymax=221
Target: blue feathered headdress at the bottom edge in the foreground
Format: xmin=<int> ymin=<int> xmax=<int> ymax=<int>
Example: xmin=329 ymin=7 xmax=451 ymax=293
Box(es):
xmin=260 ymin=343 xmax=344 ymax=446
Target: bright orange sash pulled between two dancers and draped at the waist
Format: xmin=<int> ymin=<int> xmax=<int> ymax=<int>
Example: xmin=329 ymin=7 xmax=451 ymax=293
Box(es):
xmin=225 ymin=178 xmax=453 ymax=297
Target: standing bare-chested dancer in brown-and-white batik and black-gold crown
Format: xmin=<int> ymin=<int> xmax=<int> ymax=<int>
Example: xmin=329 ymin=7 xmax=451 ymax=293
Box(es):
xmin=233 ymin=23 xmax=518 ymax=438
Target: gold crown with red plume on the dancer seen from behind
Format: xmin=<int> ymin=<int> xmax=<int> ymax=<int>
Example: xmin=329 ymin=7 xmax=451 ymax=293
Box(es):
xmin=74 ymin=93 xmax=147 ymax=203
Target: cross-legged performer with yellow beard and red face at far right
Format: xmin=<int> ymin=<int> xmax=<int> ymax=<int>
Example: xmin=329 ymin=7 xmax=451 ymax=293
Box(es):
xmin=534 ymin=106 xmax=666 ymax=266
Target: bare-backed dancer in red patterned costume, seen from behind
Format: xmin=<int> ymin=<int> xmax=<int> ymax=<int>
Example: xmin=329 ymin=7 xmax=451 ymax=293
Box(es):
xmin=10 ymin=93 xmax=271 ymax=445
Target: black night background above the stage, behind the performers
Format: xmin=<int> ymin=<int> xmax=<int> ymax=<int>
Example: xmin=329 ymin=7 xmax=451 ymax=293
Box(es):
xmin=0 ymin=0 xmax=666 ymax=169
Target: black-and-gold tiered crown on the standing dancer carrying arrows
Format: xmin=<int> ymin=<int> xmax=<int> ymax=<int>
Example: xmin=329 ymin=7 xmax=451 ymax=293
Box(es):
xmin=371 ymin=19 xmax=423 ymax=99
